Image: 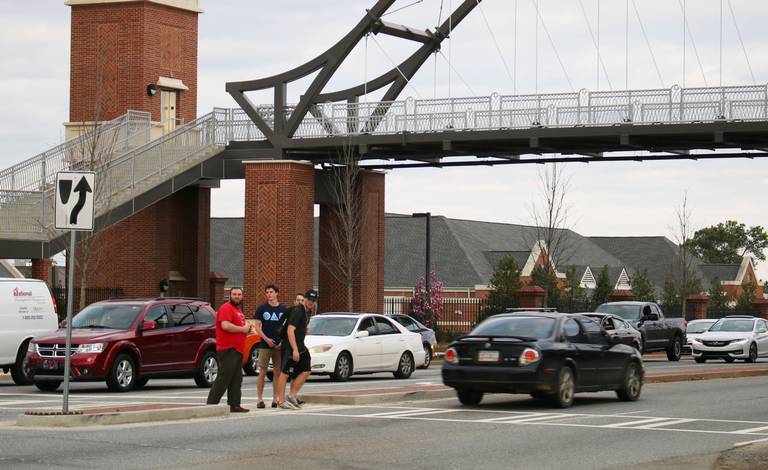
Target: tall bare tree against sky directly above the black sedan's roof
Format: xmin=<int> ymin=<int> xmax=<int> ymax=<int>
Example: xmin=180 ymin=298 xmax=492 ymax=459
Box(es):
xmin=528 ymin=163 xmax=575 ymax=307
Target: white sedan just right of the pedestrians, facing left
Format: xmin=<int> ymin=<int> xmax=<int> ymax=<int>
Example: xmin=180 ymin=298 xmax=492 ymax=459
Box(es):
xmin=304 ymin=313 xmax=424 ymax=381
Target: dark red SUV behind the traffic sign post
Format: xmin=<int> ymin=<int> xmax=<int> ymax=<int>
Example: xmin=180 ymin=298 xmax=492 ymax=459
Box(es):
xmin=27 ymin=297 xmax=219 ymax=392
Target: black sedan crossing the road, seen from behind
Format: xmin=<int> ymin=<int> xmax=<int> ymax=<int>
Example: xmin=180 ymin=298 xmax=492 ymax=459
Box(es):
xmin=442 ymin=312 xmax=645 ymax=408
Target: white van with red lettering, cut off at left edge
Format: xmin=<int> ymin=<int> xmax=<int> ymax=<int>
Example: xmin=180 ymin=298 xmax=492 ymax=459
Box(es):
xmin=0 ymin=278 xmax=59 ymax=385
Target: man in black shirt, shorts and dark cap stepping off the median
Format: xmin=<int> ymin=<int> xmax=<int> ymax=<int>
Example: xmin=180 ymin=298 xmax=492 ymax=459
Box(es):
xmin=277 ymin=290 xmax=317 ymax=409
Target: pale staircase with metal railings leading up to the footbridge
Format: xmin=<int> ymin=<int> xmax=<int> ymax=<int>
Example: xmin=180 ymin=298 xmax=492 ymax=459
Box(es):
xmin=0 ymin=109 xmax=228 ymax=242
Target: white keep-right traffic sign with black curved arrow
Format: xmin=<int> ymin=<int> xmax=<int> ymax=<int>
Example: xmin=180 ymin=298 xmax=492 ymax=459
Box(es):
xmin=56 ymin=171 xmax=96 ymax=230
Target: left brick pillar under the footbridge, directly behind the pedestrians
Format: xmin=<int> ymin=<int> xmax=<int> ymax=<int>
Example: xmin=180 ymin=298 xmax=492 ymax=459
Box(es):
xmin=243 ymin=160 xmax=310 ymax=316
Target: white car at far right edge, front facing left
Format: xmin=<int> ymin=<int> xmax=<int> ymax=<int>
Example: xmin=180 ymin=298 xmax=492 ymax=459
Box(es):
xmin=691 ymin=315 xmax=768 ymax=363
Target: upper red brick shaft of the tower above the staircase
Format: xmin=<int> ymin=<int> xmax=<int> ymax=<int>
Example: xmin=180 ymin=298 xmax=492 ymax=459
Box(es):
xmin=69 ymin=2 xmax=198 ymax=122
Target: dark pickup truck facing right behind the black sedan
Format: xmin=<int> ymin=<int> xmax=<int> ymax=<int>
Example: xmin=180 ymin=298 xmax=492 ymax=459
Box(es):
xmin=595 ymin=302 xmax=686 ymax=361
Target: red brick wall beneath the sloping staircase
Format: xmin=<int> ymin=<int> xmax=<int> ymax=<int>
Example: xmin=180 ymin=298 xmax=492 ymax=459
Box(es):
xmin=75 ymin=186 xmax=210 ymax=298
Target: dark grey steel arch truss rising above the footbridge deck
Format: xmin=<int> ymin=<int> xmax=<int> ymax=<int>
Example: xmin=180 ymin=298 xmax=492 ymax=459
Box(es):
xmin=226 ymin=0 xmax=482 ymax=148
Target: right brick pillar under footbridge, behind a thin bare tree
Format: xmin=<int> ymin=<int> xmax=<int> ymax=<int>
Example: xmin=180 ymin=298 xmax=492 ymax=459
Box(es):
xmin=319 ymin=171 xmax=384 ymax=312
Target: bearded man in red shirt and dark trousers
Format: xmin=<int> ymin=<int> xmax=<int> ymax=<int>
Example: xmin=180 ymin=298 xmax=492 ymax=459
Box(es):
xmin=206 ymin=287 xmax=254 ymax=413
